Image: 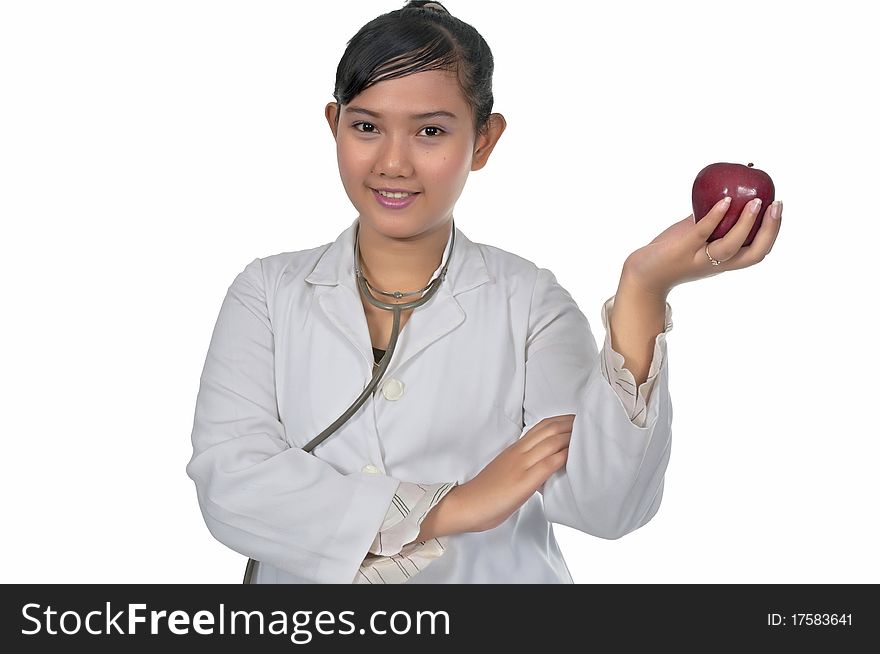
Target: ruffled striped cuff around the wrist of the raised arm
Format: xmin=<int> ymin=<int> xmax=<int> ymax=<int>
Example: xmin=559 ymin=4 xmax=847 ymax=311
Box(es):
xmin=600 ymin=295 xmax=672 ymax=427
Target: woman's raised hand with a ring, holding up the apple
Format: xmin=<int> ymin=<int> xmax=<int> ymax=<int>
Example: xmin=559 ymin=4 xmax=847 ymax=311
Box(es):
xmin=624 ymin=195 xmax=782 ymax=298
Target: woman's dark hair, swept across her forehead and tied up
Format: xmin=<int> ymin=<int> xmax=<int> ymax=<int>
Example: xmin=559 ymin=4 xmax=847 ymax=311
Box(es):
xmin=333 ymin=0 xmax=495 ymax=140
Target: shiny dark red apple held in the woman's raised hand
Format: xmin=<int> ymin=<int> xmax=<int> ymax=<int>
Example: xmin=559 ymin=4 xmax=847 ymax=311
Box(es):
xmin=691 ymin=162 xmax=776 ymax=247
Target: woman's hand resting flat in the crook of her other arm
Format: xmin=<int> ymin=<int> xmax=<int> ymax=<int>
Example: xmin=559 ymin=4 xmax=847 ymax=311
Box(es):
xmin=444 ymin=413 xmax=575 ymax=531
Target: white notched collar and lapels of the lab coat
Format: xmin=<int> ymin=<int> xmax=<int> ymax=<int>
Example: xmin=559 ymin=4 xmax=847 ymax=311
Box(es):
xmin=305 ymin=219 xmax=493 ymax=379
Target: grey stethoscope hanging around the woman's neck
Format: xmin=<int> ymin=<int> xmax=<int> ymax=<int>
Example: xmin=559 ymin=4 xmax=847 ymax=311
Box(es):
xmin=243 ymin=220 xmax=455 ymax=584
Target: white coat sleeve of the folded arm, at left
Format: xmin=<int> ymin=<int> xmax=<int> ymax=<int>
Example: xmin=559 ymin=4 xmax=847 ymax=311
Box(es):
xmin=186 ymin=258 xmax=400 ymax=584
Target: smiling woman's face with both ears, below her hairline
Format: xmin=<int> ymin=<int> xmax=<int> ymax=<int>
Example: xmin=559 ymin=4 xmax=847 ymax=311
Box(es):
xmin=326 ymin=70 xmax=503 ymax=238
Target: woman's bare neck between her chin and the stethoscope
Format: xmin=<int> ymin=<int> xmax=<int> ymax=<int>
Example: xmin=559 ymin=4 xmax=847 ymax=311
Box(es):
xmin=358 ymin=220 xmax=452 ymax=300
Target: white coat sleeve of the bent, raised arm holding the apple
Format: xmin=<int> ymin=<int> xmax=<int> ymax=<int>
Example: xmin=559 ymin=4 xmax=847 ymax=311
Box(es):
xmin=522 ymin=268 xmax=672 ymax=539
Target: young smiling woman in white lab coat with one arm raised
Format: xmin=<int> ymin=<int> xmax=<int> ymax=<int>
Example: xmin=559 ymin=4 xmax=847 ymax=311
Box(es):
xmin=187 ymin=1 xmax=781 ymax=583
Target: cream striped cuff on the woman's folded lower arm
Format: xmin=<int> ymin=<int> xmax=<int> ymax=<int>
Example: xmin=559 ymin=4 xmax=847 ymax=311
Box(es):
xmin=354 ymin=481 xmax=458 ymax=584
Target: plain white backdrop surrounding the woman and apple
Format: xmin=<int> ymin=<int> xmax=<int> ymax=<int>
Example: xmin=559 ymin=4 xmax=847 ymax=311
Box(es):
xmin=0 ymin=0 xmax=880 ymax=583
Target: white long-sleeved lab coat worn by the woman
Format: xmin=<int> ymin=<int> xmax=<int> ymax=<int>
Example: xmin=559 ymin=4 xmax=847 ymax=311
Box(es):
xmin=187 ymin=220 xmax=672 ymax=584
